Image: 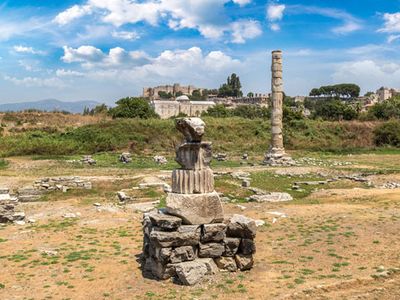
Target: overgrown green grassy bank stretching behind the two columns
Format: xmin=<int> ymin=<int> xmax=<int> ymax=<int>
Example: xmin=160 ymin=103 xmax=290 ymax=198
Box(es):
xmin=0 ymin=117 xmax=388 ymax=158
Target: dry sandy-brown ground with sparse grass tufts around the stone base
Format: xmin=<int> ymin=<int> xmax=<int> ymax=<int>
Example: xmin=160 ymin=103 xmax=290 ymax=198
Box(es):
xmin=0 ymin=155 xmax=400 ymax=299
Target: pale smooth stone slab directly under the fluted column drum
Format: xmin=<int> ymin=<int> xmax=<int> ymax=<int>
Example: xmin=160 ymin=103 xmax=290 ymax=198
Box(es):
xmin=166 ymin=192 xmax=224 ymax=225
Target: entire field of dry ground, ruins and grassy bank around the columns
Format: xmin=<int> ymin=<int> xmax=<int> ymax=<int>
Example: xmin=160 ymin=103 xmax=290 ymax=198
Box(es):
xmin=0 ymin=113 xmax=400 ymax=299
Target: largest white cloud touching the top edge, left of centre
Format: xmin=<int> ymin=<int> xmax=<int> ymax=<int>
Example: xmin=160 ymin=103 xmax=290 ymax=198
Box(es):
xmin=54 ymin=0 xmax=255 ymax=39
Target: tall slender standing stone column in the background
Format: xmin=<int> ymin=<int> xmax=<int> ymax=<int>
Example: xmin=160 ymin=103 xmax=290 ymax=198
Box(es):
xmin=264 ymin=50 xmax=294 ymax=166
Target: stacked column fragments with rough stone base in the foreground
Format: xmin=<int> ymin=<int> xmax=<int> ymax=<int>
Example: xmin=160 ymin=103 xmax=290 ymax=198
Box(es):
xmin=143 ymin=118 xmax=256 ymax=285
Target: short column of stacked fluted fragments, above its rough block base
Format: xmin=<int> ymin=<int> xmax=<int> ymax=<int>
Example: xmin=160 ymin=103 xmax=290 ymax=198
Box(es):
xmin=166 ymin=118 xmax=223 ymax=224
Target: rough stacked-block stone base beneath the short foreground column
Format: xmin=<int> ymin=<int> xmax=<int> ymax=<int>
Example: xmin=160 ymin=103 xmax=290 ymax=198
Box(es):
xmin=142 ymin=211 xmax=256 ymax=285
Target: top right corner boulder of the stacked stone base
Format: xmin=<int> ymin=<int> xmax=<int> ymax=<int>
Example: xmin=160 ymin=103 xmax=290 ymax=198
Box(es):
xmin=226 ymin=214 xmax=257 ymax=239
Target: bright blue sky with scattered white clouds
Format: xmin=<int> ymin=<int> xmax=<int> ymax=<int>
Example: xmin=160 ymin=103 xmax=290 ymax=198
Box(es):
xmin=0 ymin=0 xmax=400 ymax=104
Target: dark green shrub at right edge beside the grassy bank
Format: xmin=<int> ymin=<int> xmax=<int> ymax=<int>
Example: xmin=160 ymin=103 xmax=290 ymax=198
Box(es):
xmin=374 ymin=120 xmax=400 ymax=147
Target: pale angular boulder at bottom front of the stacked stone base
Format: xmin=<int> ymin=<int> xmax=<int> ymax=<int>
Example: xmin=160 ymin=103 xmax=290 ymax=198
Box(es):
xmin=175 ymin=261 xmax=208 ymax=285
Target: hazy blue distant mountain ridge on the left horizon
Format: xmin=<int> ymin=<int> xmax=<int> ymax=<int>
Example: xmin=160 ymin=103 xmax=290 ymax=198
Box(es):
xmin=0 ymin=99 xmax=100 ymax=113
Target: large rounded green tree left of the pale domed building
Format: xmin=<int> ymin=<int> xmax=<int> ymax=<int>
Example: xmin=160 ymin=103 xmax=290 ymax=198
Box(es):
xmin=109 ymin=97 xmax=158 ymax=119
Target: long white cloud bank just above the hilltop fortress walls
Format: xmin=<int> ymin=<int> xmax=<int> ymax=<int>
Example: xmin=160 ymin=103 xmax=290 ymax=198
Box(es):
xmin=57 ymin=47 xmax=241 ymax=86
